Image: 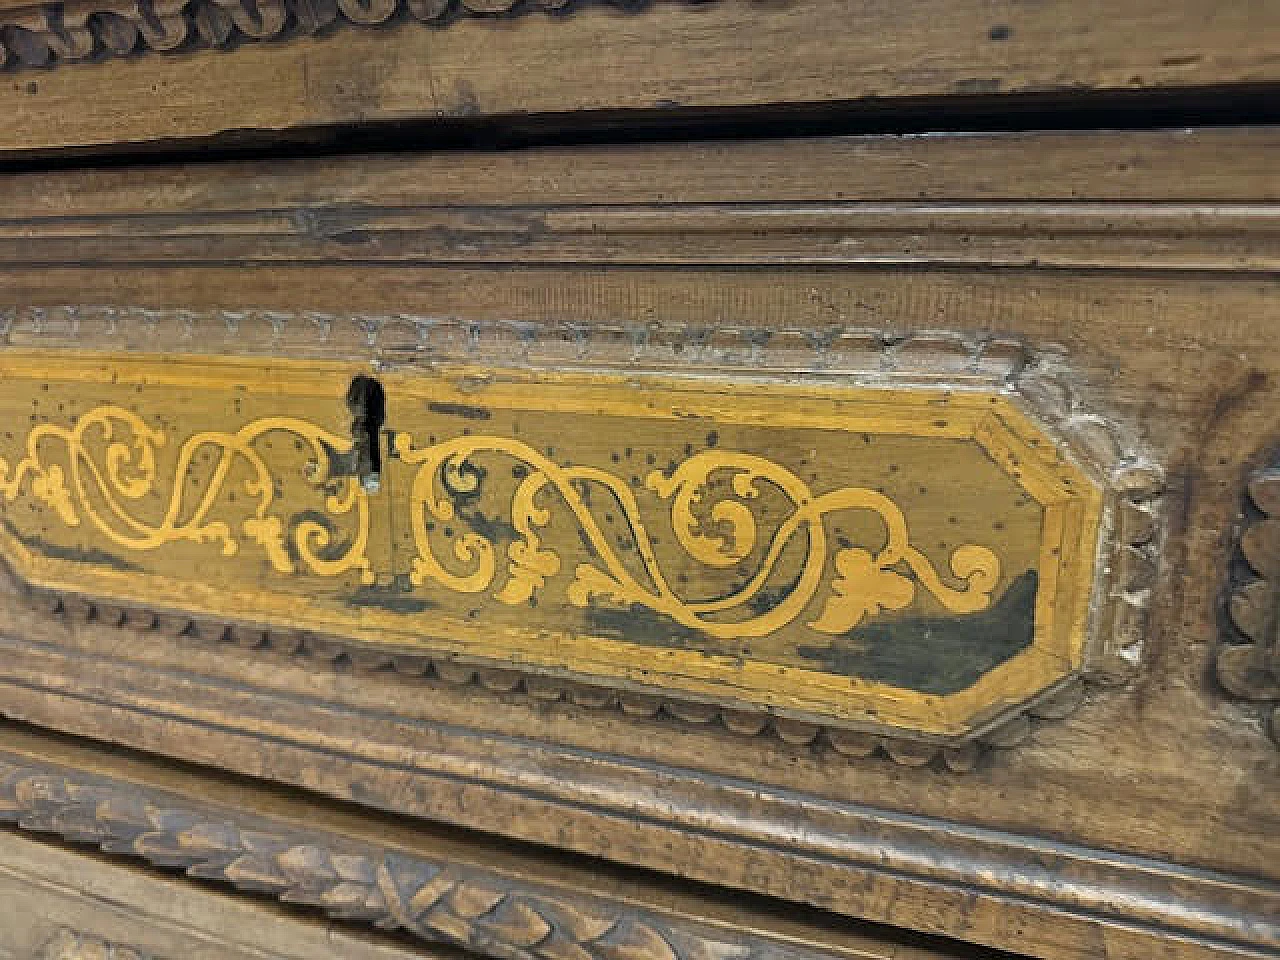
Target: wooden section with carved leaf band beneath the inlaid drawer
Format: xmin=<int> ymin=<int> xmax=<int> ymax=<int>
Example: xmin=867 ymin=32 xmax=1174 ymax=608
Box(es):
xmin=0 ymin=726 xmax=969 ymax=960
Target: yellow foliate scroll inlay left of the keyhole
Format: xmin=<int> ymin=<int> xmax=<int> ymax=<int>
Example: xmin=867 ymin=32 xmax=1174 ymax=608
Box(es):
xmin=0 ymin=406 xmax=374 ymax=582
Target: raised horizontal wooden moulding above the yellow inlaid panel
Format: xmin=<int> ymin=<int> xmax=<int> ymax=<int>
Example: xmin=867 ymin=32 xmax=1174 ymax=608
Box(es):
xmin=0 ymin=199 xmax=1280 ymax=275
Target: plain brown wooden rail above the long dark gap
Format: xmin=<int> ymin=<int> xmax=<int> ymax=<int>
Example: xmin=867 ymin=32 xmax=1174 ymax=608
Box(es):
xmin=0 ymin=0 xmax=1280 ymax=150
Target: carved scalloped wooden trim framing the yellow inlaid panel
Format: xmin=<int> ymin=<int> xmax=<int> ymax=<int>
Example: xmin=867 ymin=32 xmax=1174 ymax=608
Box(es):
xmin=0 ymin=306 xmax=1164 ymax=772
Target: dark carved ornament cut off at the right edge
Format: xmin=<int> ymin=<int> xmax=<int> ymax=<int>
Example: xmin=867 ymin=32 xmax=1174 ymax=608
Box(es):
xmin=1216 ymin=465 xmax=1280 ymax=745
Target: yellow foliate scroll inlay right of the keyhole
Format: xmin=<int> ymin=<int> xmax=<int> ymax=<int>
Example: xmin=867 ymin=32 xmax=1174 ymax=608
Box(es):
xmin=397 ymin=434 xmax=1000 ymax=639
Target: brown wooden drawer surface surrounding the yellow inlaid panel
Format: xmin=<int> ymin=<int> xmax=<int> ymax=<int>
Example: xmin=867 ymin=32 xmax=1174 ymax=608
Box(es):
xmin=0 ymin=129 xmax=1280 ymax=957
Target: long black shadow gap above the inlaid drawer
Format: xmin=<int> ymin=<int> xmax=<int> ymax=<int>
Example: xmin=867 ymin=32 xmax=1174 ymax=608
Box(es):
xmin=0 ymin=83 xmax=1280 ymax=173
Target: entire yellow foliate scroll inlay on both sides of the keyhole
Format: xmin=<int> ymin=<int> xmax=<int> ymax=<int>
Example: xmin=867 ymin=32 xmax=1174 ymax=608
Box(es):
xmin=0 ymin=406 xmax=1001 ymax=639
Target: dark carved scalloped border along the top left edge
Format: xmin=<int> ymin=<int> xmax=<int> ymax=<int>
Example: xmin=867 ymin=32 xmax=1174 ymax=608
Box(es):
xmin=0 ymin=0 xmax=665 ymax=68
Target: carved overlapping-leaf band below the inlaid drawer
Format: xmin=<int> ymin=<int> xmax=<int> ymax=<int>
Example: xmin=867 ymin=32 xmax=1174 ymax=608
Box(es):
xmin=0 ymin=756 xmax=828 ymax=960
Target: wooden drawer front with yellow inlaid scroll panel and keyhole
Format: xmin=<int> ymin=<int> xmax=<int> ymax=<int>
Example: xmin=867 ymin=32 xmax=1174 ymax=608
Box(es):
xmin=0 ymin=129 xmax=1280 ymax=956
